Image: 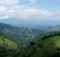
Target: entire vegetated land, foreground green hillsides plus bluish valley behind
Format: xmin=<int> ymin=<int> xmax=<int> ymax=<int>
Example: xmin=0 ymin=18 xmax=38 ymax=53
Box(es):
xmin=0 ymin=23 xmax=60 ymax=57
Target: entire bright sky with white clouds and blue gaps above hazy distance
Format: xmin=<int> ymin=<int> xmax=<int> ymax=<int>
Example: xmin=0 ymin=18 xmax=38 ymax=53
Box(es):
xmin=0 ymin=0 xmax=60 ymax=25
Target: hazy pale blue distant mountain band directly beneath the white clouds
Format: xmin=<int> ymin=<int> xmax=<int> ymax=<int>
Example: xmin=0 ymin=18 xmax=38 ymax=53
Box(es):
xmin=0 ymin=18 xmax=60 ymax=28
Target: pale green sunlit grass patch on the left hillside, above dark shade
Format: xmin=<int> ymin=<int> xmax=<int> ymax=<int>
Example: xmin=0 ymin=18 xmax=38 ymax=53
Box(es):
xmin=0 ymin=37 xmax=18 ymax=49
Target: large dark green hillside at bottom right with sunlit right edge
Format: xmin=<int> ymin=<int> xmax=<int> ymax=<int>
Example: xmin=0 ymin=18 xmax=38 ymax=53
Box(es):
xmin=20 ymin=35 xmax=60 ymax=57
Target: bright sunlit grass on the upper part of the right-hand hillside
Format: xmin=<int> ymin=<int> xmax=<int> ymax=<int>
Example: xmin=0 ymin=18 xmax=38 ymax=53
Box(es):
xmin=42 ymin=36 xmax=60 ymax=48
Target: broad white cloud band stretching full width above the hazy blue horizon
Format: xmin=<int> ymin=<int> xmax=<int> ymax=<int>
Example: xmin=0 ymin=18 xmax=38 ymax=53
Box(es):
xmin=0 ymin=6 xmax=60 ymax=20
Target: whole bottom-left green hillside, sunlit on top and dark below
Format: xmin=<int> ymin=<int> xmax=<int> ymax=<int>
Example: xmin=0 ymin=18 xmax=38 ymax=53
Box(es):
xmin=0 ymin=36 xmax=19 ymax=57
